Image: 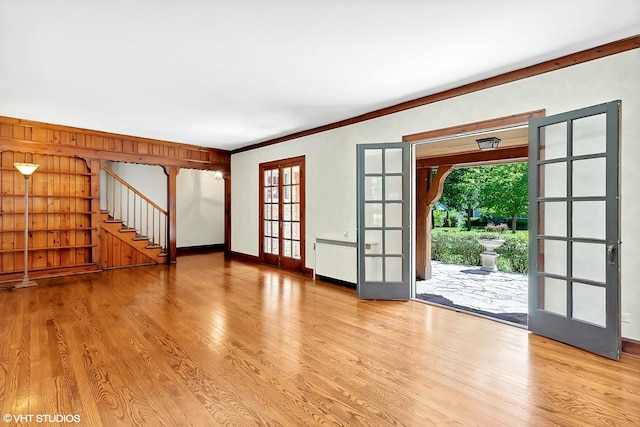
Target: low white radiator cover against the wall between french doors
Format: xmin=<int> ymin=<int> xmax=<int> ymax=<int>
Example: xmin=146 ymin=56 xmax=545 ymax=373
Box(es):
xmin=314 ymin=238 xmax=358 ymax=285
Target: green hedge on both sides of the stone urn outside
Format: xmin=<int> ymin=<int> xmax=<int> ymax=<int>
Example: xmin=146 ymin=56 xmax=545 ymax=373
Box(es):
xmin=431 ymin=229 xmax=529 ymax=273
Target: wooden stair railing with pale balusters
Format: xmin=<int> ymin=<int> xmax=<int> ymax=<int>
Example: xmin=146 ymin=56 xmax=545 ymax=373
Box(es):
xmin=102 ymin=167 xmax=168 ymax=252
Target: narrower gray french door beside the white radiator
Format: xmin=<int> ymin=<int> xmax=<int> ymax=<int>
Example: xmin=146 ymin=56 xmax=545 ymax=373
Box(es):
xmin=357 ymin=143 xmax=411 ymax=300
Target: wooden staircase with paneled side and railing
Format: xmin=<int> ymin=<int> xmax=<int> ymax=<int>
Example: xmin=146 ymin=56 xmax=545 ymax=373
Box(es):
xmin=100 ymin=168 xmax=168 ymax=268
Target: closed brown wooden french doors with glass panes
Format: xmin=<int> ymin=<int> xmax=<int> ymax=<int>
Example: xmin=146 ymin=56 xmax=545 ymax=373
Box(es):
xmin=259 ymin=156 xmax=305 ymax=271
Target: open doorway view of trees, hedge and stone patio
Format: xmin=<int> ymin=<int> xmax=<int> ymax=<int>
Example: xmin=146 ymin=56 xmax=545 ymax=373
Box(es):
xmin=415 ymin=161 xmax=529 ymax=327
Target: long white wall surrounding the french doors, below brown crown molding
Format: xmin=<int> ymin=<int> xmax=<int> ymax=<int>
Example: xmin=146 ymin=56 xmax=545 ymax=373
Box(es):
xmin=231 ymin=49 xmax=640 ymax=340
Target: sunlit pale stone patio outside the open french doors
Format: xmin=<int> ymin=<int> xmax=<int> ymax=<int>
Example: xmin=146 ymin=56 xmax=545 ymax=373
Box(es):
xmin=416 ymin=261 xmax=528 ymax=324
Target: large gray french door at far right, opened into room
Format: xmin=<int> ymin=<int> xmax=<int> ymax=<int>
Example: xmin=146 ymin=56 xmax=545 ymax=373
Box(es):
xmin=529 ymin=101 xmax=620 ymax=359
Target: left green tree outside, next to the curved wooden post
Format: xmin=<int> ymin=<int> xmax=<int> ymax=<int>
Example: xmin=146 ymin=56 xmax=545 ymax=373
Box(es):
xmin=439 ymin=167 xmax=483 ymax=230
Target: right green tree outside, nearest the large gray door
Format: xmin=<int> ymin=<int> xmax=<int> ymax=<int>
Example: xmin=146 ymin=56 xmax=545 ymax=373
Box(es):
xmin=480 ymin=162 xmax=529 ymax=233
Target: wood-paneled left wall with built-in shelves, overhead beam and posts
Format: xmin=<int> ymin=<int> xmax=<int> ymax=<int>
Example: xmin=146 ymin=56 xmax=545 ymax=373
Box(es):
xmin=0 ymin=116 xmax=231 ymax=281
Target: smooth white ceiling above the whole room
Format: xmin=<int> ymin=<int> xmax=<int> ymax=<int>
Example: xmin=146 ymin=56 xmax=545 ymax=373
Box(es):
xmin=0 ymin=0 xmax=640 ymax=149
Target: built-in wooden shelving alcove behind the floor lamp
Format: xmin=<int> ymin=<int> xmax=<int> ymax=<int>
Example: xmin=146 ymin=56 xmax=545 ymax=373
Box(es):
xmin=0 ymin=151 xmax=95 ymax=277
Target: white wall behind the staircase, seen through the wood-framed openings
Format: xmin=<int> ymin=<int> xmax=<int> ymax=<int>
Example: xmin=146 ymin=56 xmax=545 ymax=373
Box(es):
xmin=107 ymin=162 xmax=224 ymax=248
